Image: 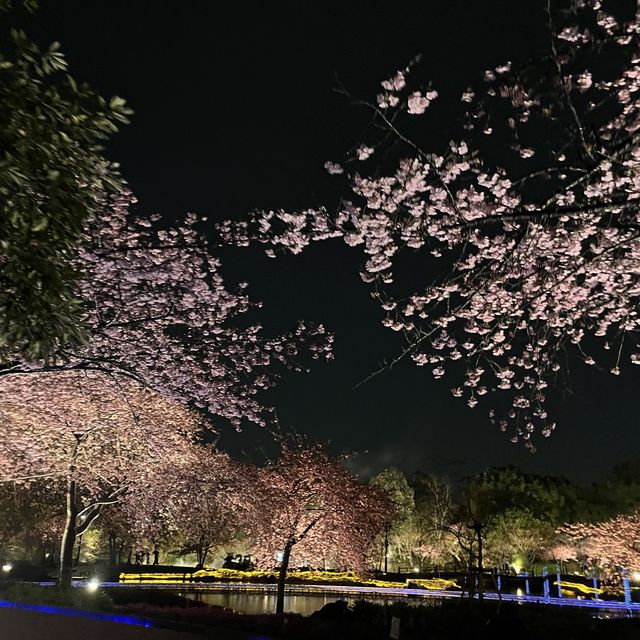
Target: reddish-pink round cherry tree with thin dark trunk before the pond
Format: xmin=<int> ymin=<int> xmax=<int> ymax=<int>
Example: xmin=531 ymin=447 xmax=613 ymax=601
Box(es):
xmin=245 ymin=443 xmax=390 ymax=612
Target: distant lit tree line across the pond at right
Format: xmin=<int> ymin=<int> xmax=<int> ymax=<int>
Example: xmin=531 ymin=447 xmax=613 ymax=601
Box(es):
xmin=371 ymin=460 xmax=640 ymax=584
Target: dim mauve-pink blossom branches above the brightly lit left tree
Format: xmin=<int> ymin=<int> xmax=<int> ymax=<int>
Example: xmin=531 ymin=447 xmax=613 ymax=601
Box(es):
xmin=0 ymin=196 xmax=331 ymax=427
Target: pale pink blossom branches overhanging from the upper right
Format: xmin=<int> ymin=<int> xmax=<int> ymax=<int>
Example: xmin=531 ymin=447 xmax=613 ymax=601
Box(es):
xmin=221 ymin=0 xmax=640 ymax=449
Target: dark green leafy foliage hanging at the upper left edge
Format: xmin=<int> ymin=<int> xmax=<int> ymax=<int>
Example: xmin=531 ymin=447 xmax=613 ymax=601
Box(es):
xmin=0 ymin=0 xmax=131 ymax=360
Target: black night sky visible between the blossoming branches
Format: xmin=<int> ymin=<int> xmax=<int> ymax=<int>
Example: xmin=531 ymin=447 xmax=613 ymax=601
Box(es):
xmin=23 ymin=0 xmax=640 ymax=480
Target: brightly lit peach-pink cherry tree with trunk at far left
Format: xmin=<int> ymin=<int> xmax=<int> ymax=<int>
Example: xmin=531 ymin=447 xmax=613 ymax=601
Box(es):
xmin=0 ymin=371 xmax=202 ymax=585
